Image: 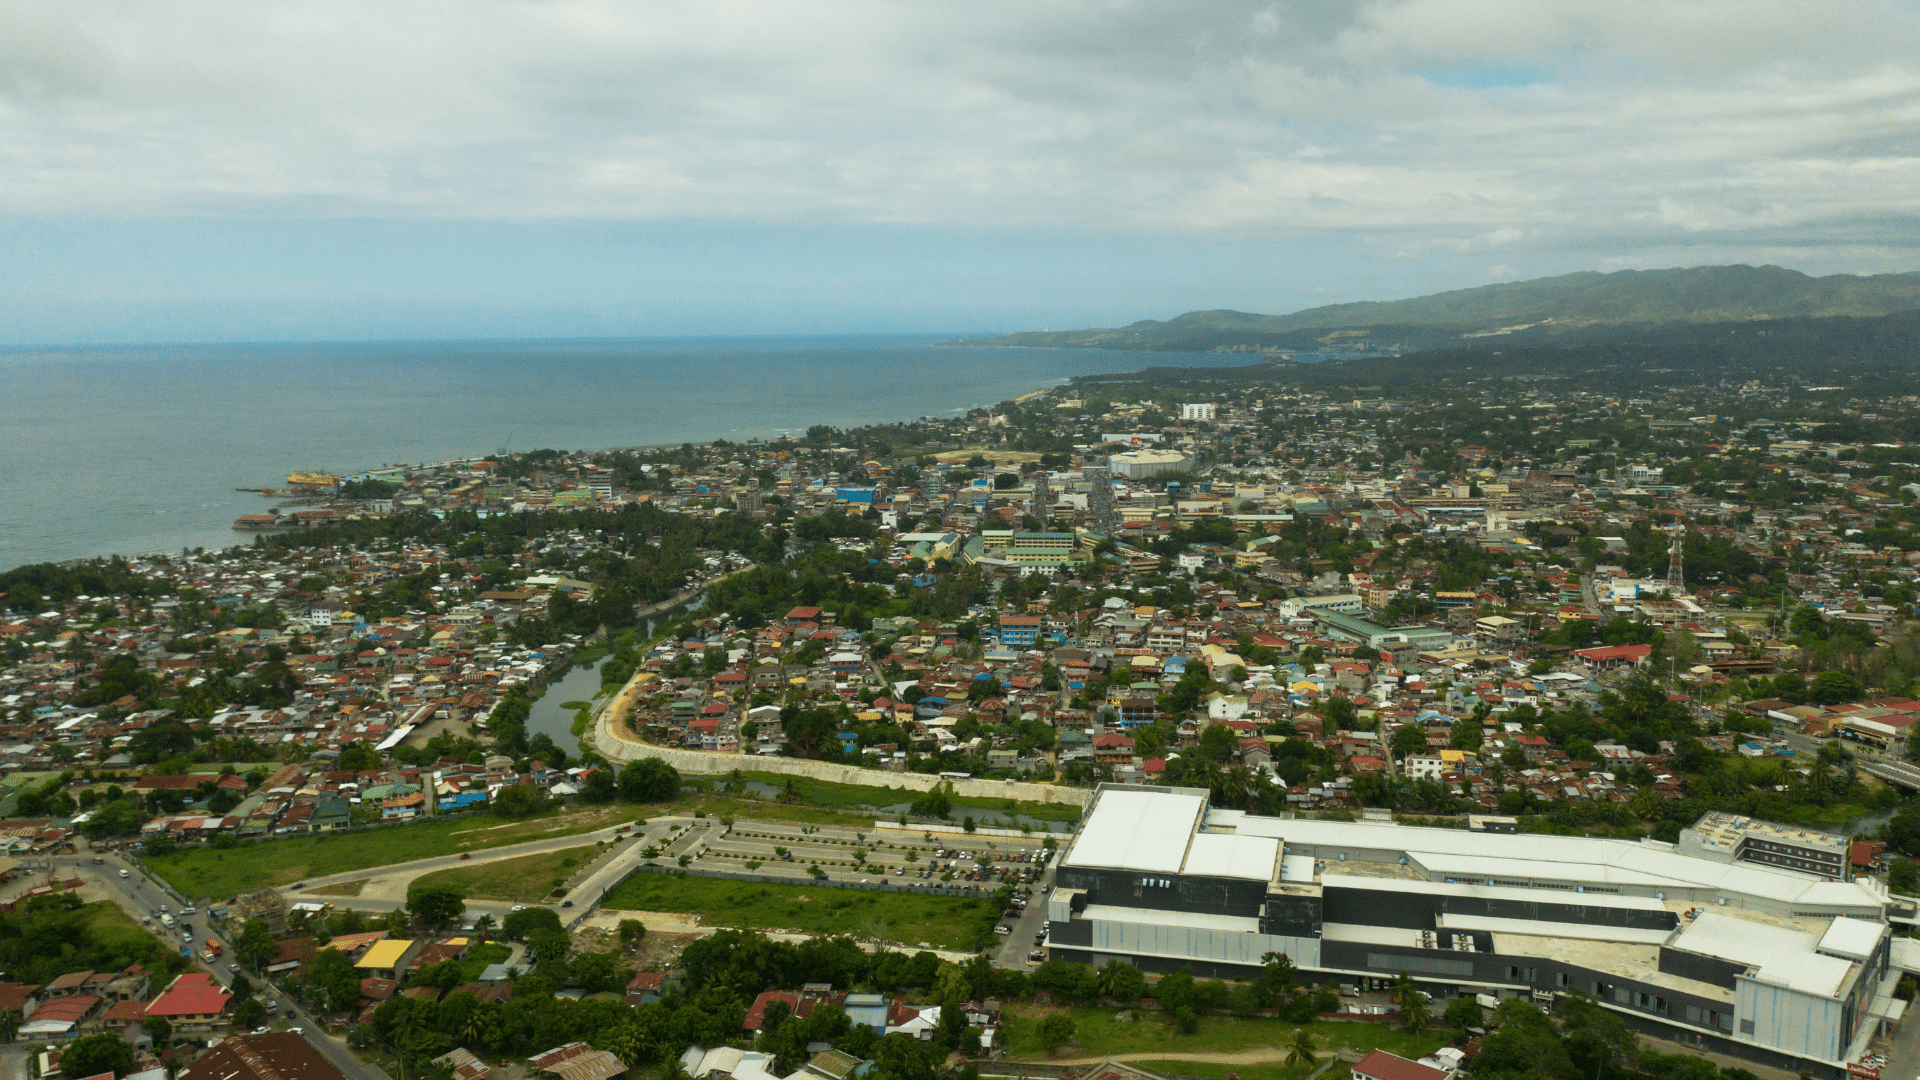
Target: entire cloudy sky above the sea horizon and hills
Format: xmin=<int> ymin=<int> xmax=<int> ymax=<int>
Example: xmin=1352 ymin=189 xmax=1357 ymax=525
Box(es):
xmin=0 ymin=0 xmax=1920 ymax=342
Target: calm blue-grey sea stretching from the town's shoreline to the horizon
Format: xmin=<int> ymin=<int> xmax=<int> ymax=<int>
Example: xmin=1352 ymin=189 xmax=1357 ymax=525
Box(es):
xmin=0 ymin=334 xmax=1259 ymax=567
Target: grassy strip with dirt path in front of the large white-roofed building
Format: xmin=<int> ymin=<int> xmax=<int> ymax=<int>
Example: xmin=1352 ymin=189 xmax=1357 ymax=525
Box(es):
xmin=1004 ymin=1005 xmax=1450 ymax=1060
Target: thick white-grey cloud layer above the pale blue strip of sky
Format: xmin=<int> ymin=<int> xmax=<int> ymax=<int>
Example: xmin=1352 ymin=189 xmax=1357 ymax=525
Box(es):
xmin=0 ymin=0 xmax=1920 ymax=267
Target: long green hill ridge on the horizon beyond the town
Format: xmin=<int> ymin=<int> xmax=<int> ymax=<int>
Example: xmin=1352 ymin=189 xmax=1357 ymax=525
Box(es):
xmin=948 ymin=265 xmax=1920 ymax=352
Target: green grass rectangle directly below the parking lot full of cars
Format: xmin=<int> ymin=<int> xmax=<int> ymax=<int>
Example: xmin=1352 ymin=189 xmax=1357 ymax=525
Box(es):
xmin=601 ymin=872 xmax=995 ymax=949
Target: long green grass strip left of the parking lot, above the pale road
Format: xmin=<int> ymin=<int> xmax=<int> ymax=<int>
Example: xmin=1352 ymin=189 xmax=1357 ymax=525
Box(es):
xmin=146 ymin=805 xmax=660 ymax=899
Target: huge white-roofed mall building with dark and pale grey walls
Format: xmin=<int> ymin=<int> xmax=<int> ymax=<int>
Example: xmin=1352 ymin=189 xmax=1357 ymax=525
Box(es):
xmin=1046 ymin=784 xmax=1920 ymax=1078
